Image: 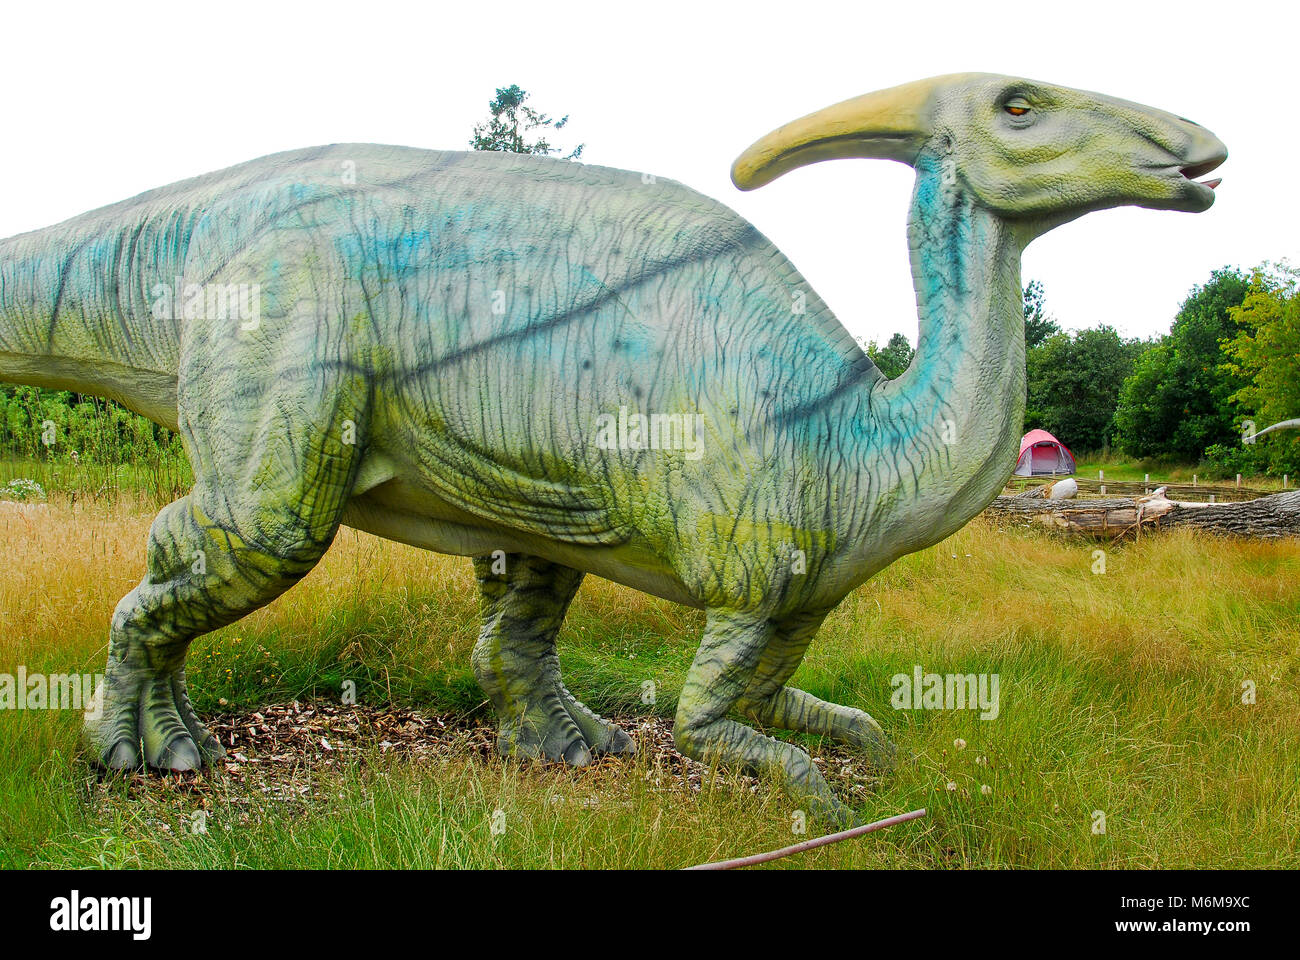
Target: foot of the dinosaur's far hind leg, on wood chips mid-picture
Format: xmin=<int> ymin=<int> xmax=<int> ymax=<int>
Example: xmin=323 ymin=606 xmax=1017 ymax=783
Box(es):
xmin=497 ymin=684 xmax=636 ymax=766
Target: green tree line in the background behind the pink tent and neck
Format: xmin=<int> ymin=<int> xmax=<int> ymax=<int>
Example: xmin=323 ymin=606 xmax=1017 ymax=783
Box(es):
xmin=863 ymin=263 xmax=1300 ymax=476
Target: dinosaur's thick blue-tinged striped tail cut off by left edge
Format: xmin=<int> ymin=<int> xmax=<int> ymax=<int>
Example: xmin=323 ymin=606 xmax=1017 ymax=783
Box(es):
xmin=0 ymin=222 xmax=179 ymax=428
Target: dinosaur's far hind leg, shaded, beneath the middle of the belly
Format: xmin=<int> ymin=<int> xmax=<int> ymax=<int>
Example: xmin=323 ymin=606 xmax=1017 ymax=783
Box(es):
xmin=472 ymin=554 xmax=636 ymax=766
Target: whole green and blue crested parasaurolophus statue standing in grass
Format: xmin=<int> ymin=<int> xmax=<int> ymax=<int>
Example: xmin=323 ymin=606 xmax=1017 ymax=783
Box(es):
xmin=0 ymin=74 xmax=1226 ymax=820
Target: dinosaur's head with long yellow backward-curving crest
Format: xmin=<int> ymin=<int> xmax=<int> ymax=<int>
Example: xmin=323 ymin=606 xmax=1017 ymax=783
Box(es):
xmin=732 ymin=73 xmax=1227 ymax=235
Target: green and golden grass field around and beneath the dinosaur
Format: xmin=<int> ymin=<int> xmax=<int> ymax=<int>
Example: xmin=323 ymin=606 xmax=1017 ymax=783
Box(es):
xmin=0 ymin=498 xmax=1300 ymax=868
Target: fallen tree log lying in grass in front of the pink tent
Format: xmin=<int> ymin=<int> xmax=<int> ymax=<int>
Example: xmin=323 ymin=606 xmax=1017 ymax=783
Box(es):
xmin=985 ymin=490 xmax=1300 ymax=539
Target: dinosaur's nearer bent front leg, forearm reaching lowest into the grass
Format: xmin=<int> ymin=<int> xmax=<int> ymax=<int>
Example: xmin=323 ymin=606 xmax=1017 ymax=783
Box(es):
xmin=672 ymin=609 xmax=854 ymax=822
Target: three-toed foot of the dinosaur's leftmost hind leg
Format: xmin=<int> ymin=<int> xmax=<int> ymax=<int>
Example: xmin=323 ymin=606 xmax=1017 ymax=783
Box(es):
xmin=81 ymin=670 xmax=225 ymax=773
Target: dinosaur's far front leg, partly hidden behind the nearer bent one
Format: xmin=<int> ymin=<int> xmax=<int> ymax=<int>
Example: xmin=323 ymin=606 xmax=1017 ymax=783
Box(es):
xmin=740 ymin=614 xmax=894 ymax=769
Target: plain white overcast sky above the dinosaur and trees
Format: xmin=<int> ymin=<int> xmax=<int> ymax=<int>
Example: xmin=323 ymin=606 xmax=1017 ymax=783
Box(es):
xmin=0 ymin=0 xmax=1300 ymax=341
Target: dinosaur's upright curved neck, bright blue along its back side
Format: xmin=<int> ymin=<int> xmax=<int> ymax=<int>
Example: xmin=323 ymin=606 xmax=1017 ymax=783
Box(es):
xmin=863 ymin=159 xmax=1024 ymax=553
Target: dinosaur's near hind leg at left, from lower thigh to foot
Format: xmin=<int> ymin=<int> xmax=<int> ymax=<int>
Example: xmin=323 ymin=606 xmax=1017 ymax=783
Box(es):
xmin=82 ymin=424 xmax=354 ymax=770
